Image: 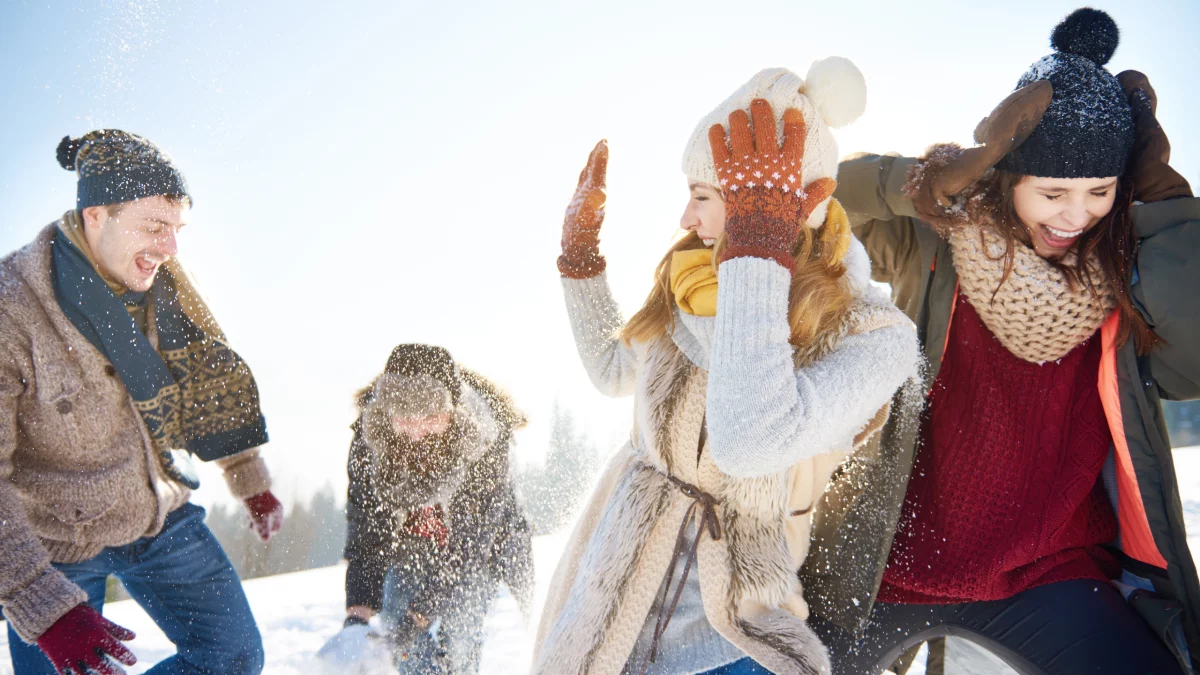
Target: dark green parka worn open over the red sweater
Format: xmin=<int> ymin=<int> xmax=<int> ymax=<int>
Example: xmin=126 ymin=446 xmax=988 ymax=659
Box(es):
xmin=802 ymin=155 xmax=1200 ymax=668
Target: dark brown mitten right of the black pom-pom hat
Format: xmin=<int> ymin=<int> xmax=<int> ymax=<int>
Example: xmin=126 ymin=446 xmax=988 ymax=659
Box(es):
xmin=1117 ymin=71 xmax=1192 ymax=203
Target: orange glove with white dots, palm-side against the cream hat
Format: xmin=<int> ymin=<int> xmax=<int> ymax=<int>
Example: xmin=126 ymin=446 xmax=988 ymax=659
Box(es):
xmin=708 ymin=98 xmax=838 ymax=271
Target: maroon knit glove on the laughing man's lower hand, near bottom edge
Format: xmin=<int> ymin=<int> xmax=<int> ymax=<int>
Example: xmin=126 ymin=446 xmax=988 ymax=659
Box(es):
xmin=37 ymin=604 xmax=138 ymax=675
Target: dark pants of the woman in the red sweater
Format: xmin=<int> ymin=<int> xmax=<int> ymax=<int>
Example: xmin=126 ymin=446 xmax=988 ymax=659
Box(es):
xmin=810 ymin=580 xmax=1182 ymax=675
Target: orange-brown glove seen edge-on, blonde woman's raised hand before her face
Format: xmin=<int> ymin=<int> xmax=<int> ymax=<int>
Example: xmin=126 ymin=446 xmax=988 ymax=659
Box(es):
xmin=558 ymin=141 xmax=608 ymax=279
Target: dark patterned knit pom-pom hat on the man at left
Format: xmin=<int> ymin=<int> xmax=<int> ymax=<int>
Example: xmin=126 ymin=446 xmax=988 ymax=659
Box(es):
xmin=58 ymin=129 xmax=192 ymax=209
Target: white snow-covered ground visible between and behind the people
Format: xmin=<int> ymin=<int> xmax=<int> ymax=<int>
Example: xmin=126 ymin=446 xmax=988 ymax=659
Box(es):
xmin=0 ymin=447 xmax=1200 ymax=675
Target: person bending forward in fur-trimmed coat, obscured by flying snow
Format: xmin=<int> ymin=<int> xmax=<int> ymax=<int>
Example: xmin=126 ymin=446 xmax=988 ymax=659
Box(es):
xmin=322 ymin=345 xmax=533 ymax=675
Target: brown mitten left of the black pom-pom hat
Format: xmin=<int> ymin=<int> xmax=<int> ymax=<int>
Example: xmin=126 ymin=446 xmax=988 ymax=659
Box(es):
xmin=912 ymin=79 xmax=1054 ymax=219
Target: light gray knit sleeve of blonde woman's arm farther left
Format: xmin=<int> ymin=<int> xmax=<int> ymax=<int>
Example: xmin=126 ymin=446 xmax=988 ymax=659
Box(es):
xmin=563 ymin=274 xmax=637 ymax=396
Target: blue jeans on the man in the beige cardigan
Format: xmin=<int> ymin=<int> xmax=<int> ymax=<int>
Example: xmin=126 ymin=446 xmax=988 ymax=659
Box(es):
xmin=8 ymin=503 xmax=263 ymax=675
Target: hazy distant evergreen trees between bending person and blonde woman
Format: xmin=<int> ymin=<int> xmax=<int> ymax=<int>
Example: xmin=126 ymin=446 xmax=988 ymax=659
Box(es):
xmin=516 ymin=401 xmax=600 ymax=534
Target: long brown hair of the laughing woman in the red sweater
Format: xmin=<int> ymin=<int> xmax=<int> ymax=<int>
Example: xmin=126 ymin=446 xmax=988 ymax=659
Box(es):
xmin=968 ymin=169 xmax=1164 ymax=354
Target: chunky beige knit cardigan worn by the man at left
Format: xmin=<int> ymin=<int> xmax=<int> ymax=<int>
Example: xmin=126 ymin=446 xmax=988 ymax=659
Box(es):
xmin=0 ymin=223 xmax=270 ymax=641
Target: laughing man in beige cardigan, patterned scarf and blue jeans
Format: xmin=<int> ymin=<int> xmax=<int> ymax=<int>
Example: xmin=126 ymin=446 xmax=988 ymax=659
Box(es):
xmin=0 ymin=130 xmax=282 ymax=675
